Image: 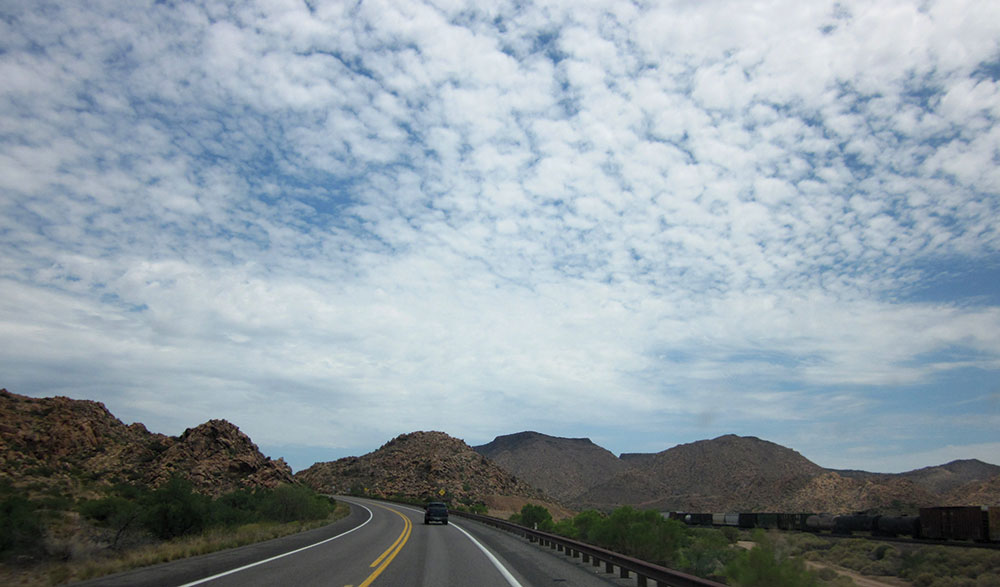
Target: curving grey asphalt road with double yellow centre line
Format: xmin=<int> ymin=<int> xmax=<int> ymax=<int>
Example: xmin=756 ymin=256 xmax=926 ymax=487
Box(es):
xmin=79 ymin=497 xmax=635 ymax=587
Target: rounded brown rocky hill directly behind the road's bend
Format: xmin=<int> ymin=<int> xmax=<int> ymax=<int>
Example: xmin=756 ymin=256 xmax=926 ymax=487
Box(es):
xmin=295 ymin=432 xmax=568 ymax=510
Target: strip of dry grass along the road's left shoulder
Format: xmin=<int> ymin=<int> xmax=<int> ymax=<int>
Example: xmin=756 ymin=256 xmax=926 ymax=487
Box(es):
xmin=0 ymin=502 xmax=350 ymax=587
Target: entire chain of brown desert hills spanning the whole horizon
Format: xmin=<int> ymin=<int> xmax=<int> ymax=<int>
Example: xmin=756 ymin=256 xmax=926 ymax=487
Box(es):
xmin=0 ymin=389 xmax=1000 ymax=515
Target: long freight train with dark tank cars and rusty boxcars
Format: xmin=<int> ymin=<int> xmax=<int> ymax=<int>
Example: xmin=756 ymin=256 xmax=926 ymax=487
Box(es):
xmin=667 ymin=506 xmax=1000 ymax=543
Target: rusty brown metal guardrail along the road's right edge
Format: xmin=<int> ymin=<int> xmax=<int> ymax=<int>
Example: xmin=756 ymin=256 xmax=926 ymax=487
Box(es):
xmin=449 ymin=510 xmax=725 ymax=587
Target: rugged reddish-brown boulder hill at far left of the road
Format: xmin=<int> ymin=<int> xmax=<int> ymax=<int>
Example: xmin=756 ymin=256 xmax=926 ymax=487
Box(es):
xmin=0 ymin=389 xmax=293 ymax=496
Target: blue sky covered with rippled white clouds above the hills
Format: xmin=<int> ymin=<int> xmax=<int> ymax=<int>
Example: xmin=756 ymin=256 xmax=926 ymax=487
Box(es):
xmin=0 ymin=0 xmax=1000 ymax=472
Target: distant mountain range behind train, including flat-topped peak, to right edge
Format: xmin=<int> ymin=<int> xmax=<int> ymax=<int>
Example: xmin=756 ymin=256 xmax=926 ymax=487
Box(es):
xmin=477 ymin=433 xmax=1000 ymax=513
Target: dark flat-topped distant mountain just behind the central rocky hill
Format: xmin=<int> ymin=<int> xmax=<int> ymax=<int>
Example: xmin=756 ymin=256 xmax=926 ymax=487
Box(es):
xmin=474 ymin=432 xmax=628 ymax=503
